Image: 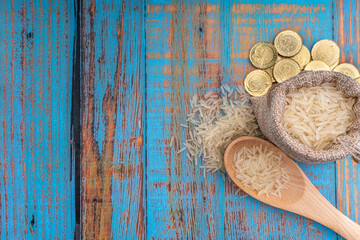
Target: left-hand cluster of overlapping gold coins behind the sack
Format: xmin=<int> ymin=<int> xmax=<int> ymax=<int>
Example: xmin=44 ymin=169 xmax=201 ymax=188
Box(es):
xmin=244 ymin=30 xmax=304 ymax=96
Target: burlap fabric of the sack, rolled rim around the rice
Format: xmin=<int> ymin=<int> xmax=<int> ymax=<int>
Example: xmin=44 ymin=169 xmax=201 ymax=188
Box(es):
xmin=251 ymin=71 xmax=360 ymax=164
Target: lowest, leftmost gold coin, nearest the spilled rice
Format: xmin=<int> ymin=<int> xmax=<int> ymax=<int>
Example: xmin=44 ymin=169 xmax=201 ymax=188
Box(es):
xmin=244 ymin=70 xmax=272 ymax=96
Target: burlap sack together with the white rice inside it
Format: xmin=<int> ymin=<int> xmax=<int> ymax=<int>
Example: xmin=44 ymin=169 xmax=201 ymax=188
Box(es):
xmin=251 ymin=71 xmax=360 ymax=164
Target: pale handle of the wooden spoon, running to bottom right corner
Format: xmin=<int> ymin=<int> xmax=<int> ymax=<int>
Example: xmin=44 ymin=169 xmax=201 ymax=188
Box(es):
xmin=293 ymin=186 xmax=360 ymax=240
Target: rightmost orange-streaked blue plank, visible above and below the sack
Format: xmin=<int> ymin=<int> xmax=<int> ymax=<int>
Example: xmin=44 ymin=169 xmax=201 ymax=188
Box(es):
xmin=333 ymin=0 xmax=360 ymax=234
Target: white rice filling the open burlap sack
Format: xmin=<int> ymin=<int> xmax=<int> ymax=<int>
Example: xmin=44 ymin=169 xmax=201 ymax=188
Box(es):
xmin=283 ymin=83 xmax=355 ymax=150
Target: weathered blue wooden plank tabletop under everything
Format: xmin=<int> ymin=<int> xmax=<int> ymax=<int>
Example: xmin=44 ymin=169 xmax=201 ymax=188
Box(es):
xmin=0 ymin=0 xmax=360 ymax=240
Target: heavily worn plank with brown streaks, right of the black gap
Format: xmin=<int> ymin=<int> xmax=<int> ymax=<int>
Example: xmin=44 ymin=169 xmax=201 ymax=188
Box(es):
xmin=81 ymin=0 xmax=145 ymax=239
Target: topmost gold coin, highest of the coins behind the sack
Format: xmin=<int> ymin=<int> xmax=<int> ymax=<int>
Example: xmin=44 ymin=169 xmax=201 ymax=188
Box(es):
xmin=274 ymin=30 xmax=302 ymax=57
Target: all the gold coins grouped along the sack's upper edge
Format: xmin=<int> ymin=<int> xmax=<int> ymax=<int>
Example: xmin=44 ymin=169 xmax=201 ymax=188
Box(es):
xmin=244 ymin=30 xmax=360 ymax=96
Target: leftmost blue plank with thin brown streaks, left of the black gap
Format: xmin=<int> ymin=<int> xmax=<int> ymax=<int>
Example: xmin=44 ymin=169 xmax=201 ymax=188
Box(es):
xmin=0 ymin=0 xmax=75 ymax=239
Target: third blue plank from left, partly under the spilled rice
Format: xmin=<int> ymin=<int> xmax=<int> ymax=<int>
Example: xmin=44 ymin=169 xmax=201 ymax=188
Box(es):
xmin=146 ymin=0 xmax=224 ymax=239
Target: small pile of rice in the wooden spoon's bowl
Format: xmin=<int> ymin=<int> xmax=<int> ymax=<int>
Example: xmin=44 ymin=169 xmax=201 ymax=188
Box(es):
xmin=235 ymin=146 xmax=289 ymax=197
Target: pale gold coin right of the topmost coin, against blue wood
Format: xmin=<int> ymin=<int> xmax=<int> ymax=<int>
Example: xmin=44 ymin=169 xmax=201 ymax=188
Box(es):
xmin=311 ymin=39 xmax=340 ymax=66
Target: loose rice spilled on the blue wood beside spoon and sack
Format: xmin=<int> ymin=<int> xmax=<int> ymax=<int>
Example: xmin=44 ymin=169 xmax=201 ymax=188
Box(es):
xmin=180 ymin=85 xmax=261 ymax=173
